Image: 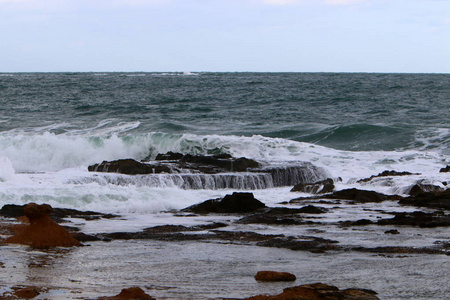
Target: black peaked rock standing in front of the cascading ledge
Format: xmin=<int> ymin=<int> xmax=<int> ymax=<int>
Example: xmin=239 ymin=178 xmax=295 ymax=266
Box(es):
xmin=183 ymin=192 xmax=266 ymax=214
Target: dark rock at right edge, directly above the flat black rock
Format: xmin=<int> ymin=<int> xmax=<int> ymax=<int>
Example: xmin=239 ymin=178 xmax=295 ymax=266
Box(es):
xmin=398 ymin=189 xmax=450 ymax=210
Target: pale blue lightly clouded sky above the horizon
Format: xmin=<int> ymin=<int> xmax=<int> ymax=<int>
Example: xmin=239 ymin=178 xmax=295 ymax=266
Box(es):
xmin=0 ymin=0 xmax=450 ymax=73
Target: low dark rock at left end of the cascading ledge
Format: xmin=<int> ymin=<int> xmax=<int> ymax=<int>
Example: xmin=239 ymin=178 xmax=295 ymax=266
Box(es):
xmin=88 ymin=159 xmax=172 ymax=175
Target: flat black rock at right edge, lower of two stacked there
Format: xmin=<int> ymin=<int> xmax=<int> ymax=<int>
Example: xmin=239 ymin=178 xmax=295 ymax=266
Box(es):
xmin=377 ymin=211 xmax=450 ymax=228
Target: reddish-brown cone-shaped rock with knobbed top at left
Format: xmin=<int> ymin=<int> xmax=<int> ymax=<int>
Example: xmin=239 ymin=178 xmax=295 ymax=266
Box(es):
xmin=4 ymin=203 xmax=81 ymax=248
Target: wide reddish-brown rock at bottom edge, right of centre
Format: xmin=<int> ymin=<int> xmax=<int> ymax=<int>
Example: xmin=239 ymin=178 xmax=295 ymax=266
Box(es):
xmin=244 ymin=283 xmax=379 ymax=300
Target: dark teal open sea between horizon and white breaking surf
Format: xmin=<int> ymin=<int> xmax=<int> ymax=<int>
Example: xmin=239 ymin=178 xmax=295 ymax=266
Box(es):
xmin=0 ymin=73 xmax=450 ymax=154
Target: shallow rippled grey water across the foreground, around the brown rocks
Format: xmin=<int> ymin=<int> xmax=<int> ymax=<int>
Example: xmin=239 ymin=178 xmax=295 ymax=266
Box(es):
xmin=0 ymin=241 xmax=450 ymax=300
